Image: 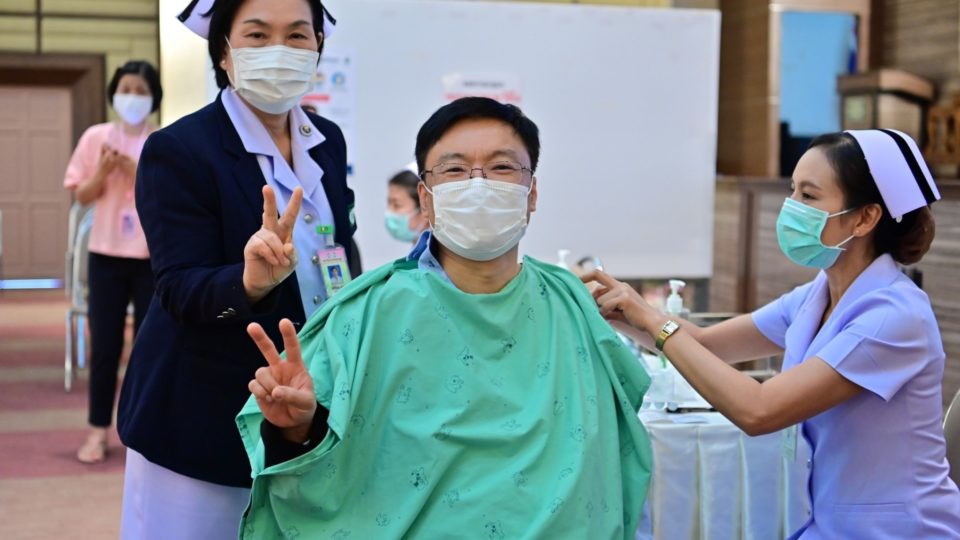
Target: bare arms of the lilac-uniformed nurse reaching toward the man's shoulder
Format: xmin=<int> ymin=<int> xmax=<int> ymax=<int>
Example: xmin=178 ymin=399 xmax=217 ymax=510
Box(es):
xmin=584 ymin=271 xmax=863 ymax=435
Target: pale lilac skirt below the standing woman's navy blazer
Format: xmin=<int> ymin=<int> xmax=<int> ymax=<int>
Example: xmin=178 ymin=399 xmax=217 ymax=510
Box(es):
xmin=120 ymin=448 xmax=250 ymax=540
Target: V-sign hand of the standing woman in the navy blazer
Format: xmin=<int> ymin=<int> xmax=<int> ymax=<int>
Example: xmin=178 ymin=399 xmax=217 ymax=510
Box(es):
xmin=243 ymin=186 xmax=303 ymax=303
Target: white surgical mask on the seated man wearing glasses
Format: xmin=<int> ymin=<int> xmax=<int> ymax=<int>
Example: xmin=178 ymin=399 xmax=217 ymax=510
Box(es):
xmin=427 ymin=178 xmax=530 ymax=261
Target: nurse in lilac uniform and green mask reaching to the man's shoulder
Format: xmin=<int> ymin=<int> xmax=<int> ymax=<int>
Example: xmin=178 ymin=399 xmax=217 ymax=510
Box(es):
xmin=583 ymin=130 xmax=960 ymax=540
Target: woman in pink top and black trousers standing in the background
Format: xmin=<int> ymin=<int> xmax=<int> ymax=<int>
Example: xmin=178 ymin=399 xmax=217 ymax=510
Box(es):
xmin=63 ymin=61 xmax=163 ymax=463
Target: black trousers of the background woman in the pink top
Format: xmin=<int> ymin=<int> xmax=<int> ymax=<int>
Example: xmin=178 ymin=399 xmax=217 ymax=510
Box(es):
xmin=87 ymin=253 xmax=153 ymax=427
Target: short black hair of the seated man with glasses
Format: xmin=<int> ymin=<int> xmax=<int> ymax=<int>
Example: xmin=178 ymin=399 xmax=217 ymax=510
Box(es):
xmin=414 ymin=97 xmax=540 ymax=171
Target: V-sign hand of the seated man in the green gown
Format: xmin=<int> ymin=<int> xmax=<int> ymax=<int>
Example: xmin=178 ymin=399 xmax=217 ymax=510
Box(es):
xmin=247 ymin=319 xmax=317 ymax=442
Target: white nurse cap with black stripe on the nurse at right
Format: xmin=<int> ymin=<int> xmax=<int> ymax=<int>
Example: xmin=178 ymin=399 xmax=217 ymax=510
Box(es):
xmin=846 ymin=129 xmax=940 ymax=221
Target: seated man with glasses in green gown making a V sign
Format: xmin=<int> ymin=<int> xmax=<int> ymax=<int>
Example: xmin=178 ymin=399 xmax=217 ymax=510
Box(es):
xmin=237 ymin=98 xmax=651 ymax=540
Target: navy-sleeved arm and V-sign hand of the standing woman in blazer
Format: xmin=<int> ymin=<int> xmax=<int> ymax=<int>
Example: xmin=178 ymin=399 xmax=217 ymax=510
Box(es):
xmin=136 ymin=131 xmax=302 ymax=323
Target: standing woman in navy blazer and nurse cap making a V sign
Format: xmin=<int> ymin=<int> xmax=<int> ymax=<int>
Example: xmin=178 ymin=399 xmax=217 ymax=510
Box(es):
xmin=117 ymin=0 xmax=356 ymax=538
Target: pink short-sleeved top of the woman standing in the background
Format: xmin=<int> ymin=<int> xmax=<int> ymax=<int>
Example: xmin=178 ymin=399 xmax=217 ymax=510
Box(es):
xmin=63 ymin=122 xmax=153 ymax=259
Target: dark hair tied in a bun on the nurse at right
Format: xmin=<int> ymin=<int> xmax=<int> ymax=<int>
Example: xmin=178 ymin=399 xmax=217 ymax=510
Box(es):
xmin=810 ymin=133 xmax=936 ymax=264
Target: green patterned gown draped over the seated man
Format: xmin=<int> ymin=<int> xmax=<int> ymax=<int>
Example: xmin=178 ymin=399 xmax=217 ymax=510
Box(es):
xmin=237 ymin=258 xmax=651 ymax=540
